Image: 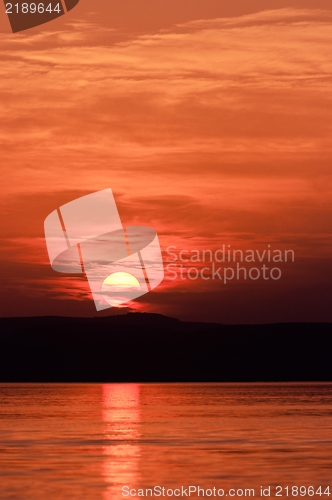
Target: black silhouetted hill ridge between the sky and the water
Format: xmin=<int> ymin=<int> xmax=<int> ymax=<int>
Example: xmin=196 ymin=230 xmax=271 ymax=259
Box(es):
xmin=0 ymin=313 xmax=332 ymax=382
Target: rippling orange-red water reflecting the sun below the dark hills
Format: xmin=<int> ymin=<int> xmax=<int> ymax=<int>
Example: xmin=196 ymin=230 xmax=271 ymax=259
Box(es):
xmin=0 ymin=383 xmax=332 ymax=500
